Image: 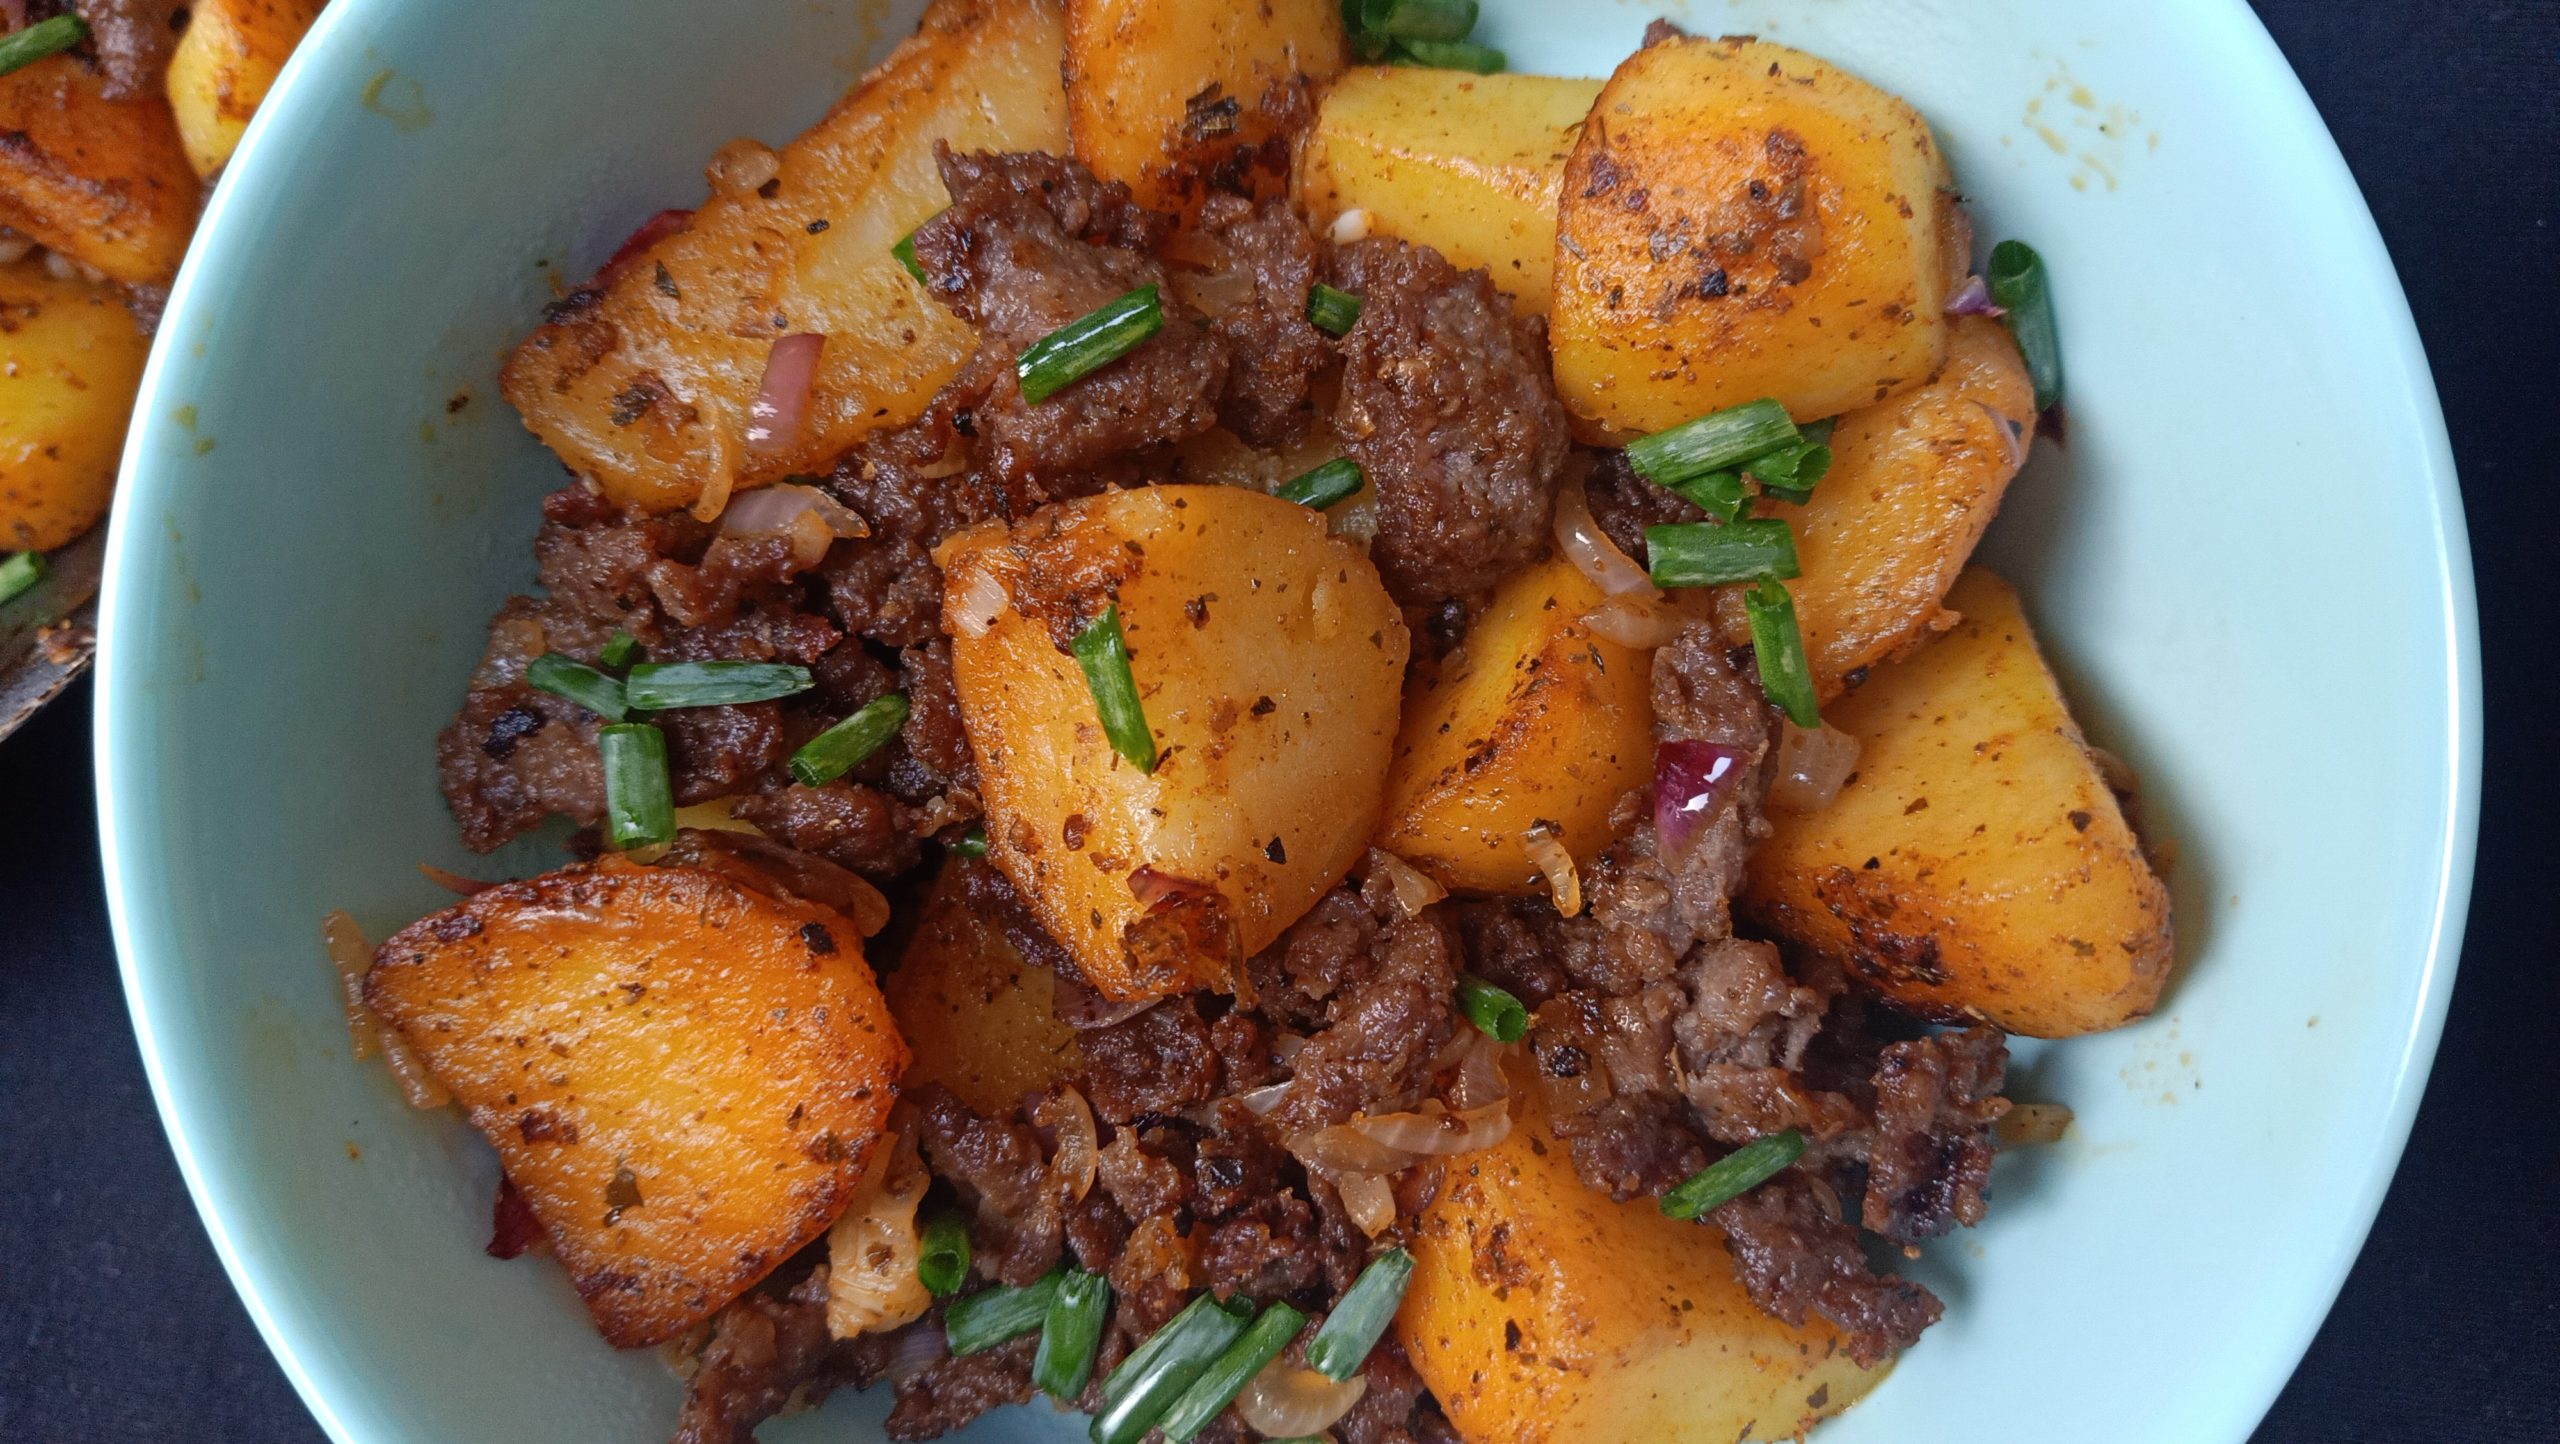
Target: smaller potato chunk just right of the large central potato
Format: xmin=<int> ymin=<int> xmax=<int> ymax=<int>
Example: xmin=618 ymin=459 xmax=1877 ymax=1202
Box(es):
xmin=1377 ymin=558 xmax=1654 ymax=894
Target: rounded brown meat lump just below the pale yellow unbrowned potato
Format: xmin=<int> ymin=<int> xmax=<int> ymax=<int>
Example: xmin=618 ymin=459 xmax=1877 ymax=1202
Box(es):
xmin=1334 ymin=238 xmax=1572 ymax=607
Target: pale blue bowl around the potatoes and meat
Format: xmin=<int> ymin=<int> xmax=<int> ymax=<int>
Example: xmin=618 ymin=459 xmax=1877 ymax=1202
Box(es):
xmin=100 ymin=0 xmax=2478 ymax=1444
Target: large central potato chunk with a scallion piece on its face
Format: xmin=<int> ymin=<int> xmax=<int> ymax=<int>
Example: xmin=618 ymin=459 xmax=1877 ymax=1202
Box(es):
xmin=937 ymin=486 xmax=1408 ymax=1001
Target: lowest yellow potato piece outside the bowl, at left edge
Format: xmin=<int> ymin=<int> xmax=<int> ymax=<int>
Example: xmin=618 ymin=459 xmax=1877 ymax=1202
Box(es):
xmin=0 ymin=259 xmax=151 ymax=550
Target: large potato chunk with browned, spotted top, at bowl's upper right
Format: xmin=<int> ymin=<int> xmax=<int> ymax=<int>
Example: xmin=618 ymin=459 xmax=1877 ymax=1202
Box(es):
xmin=1554 ymin=36 xmax=1953 ymax=440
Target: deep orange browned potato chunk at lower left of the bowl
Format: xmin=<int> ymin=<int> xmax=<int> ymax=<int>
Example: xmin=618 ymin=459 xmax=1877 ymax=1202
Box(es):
xmin=364 ymin=860 xmax=906 ymax=1347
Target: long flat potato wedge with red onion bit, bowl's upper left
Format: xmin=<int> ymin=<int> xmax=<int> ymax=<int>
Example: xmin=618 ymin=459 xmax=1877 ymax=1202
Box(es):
xmin=504 ymin=0 xmax=1068 ymax=509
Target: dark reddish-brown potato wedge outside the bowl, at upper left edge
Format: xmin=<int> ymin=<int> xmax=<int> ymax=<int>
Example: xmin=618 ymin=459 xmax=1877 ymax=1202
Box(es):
xmin=0 ymin=56 xmax=200 ymax=287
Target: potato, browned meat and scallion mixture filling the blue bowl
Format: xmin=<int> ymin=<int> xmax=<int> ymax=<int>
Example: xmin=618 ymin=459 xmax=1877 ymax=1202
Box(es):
xmin=350 ymin=0 xmax=2171 ymax=1444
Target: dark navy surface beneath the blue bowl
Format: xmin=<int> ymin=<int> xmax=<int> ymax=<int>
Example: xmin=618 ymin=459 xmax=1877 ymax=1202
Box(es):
xmin=0 ymin=0 xmax=2560 ymax=1444
